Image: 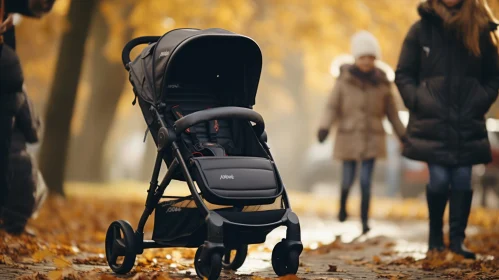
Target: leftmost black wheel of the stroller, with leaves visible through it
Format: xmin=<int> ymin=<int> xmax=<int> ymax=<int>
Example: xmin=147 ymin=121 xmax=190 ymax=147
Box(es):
xmin=106 ymin=220 xmax=137 ymax=274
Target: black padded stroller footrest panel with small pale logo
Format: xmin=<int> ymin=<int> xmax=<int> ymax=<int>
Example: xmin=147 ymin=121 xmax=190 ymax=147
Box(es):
xmin=193 ymin=157 xmax=282 ymax=205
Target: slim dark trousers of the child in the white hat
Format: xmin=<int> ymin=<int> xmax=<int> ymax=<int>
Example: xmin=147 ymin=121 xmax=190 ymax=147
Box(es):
xmin=338 ymin=159 xmax=375 ymax=233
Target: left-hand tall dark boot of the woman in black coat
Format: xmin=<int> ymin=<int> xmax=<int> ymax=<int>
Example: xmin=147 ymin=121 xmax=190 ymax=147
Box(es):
xmin=426 ymin=186 xmax=449 ymax=251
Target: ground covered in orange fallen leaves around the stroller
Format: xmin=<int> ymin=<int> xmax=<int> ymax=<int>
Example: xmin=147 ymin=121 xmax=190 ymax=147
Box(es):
xmin=0 ymin=183 xmax=499 ymax=280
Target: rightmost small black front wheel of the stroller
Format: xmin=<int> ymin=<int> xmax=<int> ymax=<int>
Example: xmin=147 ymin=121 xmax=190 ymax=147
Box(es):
xmin=272 ymin=242 xmax=300 ymax=276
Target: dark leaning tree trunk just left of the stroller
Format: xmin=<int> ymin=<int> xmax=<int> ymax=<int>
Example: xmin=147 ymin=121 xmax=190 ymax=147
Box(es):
xmin=40 ymin=0 xmax=97 ymax=195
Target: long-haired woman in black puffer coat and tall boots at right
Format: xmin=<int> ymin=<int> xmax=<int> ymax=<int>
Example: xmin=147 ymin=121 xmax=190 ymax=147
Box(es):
xmin=395 ymin=0 xmax=499 ymax=258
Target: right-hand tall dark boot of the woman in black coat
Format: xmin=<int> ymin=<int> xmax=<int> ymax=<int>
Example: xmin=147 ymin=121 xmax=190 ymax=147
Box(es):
xmin=449 ymin=190 xmax=476 ymax=259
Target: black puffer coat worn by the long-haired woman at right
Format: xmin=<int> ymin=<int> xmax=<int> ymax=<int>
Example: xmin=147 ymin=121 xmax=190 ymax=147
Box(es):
xmin=395 ymin=4 xmax=499 ymax=166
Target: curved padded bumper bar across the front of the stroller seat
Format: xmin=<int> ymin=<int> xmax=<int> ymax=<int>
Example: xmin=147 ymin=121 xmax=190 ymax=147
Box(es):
xmin=174 ymin=107 xmax=265 ymax=137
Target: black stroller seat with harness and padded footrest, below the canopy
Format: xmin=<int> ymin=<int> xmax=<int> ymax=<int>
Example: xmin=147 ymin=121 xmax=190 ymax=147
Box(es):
xmin=164 ymin=84 xmax=282 ymax=206
